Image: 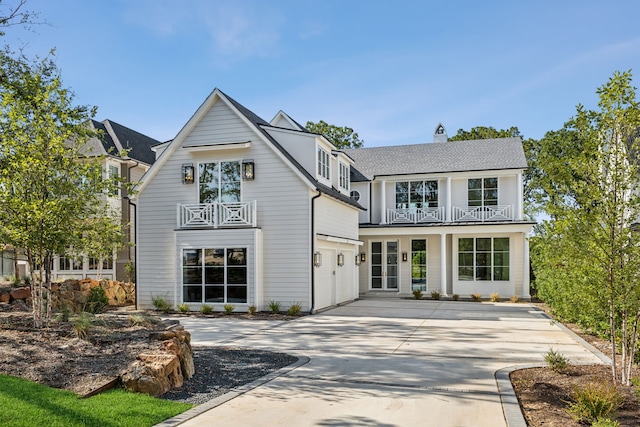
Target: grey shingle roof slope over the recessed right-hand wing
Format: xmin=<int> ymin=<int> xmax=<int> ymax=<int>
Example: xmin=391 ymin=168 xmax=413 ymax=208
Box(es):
xmin=342 ymin=138 xmax=527 ymax=181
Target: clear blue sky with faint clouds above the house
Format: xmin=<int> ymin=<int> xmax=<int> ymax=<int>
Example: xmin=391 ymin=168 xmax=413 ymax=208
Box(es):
xmin=5 ymin=0 xmax=640 ymax=147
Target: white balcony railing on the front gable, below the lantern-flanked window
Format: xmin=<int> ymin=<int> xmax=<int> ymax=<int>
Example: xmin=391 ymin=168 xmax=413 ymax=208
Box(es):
xmin=177 ymin=200 xmax=256 ymax=228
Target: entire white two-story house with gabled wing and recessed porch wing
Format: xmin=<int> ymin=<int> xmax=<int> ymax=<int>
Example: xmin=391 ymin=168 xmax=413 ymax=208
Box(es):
xmin=135 ymin=89 xmax=533 ymax=312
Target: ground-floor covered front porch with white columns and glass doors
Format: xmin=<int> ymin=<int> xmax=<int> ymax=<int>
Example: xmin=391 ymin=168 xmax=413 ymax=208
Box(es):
xmin=359 ymin=223 xmax=531 ymax=299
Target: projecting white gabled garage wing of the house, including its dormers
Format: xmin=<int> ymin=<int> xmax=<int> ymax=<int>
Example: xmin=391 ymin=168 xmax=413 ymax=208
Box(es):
xmin=135 ymin=89 xmax=362 ymax=311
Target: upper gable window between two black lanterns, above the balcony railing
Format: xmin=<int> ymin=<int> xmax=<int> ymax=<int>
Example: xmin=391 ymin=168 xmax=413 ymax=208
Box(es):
xmin=198 ymin=161 xmax=241 ymax=203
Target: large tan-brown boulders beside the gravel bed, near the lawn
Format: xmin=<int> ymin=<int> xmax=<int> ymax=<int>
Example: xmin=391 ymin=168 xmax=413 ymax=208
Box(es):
xmin=120 ymin=324 xmax=195 ymax=396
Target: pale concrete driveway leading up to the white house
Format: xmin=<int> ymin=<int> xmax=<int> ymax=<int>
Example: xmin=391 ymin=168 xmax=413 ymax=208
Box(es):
xmin=159 ymin=299 xmax=606 ymax=427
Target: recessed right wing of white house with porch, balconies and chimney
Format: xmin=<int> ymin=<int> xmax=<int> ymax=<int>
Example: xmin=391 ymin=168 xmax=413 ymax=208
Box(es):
xmin=345 ymin=124 xmax=534 ymax=299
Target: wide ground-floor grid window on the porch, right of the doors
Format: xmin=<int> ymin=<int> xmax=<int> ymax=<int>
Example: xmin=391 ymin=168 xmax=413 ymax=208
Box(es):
xmin=458 ymin=237 xmax=509 ymax=281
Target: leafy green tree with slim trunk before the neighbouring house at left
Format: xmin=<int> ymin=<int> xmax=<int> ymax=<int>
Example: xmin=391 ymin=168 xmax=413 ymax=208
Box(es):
xmin=0 ymin=51 xmax=118 ymax=326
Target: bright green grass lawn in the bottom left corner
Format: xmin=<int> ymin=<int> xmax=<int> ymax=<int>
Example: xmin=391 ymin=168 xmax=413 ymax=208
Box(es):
xmin=0 ymin=375 xmax=193 ymax=427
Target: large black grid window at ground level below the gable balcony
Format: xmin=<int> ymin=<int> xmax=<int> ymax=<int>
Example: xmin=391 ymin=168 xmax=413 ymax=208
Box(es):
xmin=182 ymin=248 xmax=247 ymax=303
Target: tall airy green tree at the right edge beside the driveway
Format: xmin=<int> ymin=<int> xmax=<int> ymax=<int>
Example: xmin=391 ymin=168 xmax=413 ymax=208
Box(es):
xmin=532 ymin=72 xmax=640 ymax=384
